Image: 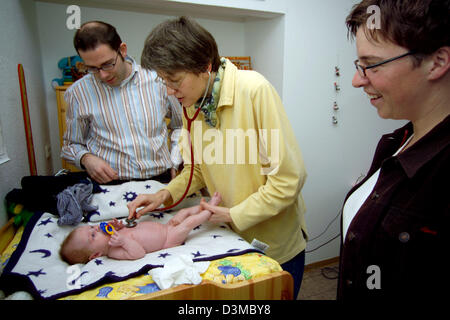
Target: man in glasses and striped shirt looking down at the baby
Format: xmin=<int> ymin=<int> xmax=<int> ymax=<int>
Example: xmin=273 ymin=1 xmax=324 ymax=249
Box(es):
xmin=61 ymin=21 xmax=182 ymax=184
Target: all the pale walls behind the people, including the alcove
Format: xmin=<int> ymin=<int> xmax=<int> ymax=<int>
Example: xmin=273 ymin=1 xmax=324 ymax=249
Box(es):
xmin=0 ymin=0 xmax=403 ymax=263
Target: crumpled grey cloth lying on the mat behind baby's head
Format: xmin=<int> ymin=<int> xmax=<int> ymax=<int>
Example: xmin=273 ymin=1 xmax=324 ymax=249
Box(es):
xmin=56 ymin=183 xmax=98 ymax=226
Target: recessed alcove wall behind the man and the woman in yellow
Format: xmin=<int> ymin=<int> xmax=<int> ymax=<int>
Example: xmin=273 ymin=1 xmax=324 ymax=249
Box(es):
xmin=36 ymin=2 xmax=251 ymax=175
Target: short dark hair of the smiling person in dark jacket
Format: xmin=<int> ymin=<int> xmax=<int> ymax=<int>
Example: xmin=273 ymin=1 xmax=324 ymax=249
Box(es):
xmin=346 ymin=0 xmax=450 ymax=63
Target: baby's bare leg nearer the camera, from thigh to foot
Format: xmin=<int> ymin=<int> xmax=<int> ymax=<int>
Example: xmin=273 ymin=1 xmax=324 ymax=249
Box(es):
xmin=164 ymin=192 xmax=222 ymax=248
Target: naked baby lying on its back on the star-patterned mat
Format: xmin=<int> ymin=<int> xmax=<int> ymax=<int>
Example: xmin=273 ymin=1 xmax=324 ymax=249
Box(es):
xmin=60 ymin=192 xmax=222 ymax=264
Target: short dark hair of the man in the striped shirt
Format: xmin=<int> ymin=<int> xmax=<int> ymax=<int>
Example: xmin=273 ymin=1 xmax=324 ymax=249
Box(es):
xmin=73 ymin=21 xmax=122 ymax=53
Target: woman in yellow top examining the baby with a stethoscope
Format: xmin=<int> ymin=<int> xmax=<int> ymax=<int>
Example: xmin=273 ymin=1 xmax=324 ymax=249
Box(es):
xmin=128 ymin=17 xmax=307 ymax=298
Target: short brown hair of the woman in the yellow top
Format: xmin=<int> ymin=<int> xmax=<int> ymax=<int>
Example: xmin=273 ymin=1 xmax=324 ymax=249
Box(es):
xmin=141 ymin=16 xmax=220 ymax=75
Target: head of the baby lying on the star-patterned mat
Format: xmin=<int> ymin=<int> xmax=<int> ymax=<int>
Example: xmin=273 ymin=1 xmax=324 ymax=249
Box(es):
xmin=59 ymin=226 xmax=109 ymax=264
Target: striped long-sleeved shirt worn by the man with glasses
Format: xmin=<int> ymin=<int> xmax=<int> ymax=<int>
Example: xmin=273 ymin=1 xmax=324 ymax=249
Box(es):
xmin=61 ymin=57 xmax=182 ymax=180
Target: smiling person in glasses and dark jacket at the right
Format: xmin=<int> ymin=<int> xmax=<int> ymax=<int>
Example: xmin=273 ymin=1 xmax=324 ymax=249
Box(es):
xmin=338 ymin=0 xmax=450 ymax=301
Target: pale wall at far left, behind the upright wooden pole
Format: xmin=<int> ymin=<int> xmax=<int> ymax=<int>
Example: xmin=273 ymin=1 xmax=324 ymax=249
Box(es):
xmin=0 ymin=0 xmax=51 ymax=226
